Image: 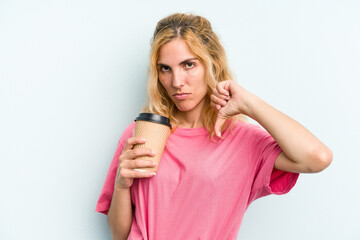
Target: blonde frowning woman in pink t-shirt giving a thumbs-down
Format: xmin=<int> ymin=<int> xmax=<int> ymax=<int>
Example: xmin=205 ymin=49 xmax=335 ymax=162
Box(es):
xmin=96 ymin=14 xmax=332 ymax=240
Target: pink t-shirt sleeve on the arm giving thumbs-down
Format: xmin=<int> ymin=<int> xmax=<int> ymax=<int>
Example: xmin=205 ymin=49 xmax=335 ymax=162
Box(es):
xmin=248 ymin=124 xmax=299 ymax=204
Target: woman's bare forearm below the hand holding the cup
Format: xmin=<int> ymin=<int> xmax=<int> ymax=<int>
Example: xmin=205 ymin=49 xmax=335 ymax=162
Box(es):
xmin=108 ymin=187 xmax=132 ymax=240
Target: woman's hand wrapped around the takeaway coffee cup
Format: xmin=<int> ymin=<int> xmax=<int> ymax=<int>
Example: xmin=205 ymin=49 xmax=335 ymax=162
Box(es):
xmin=115 ymin=137 xmax=156 ymax=189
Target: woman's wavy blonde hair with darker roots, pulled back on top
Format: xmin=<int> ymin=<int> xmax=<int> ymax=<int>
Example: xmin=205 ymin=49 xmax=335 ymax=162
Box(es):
xmin=143 ymin=13 xmax=242 ymax=139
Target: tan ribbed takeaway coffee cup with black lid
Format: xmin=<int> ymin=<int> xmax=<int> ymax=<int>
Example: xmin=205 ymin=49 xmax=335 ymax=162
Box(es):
xmin=134 ymin=113 xmax=171 ymax=172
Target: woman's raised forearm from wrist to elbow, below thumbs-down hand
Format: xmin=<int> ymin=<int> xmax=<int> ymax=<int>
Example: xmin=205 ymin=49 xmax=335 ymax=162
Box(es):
xmin=246 ymin=93 xmax=331 ymax=167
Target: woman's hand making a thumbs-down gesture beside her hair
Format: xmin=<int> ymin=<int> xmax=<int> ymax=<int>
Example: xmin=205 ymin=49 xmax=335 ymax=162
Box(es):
xmin=210 ymin=80 xmax=251 ymax=137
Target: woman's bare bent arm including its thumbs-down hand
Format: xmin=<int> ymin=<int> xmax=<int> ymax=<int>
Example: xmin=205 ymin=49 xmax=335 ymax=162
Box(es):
xmin=211 ymin=80 xmax=332 ymax=173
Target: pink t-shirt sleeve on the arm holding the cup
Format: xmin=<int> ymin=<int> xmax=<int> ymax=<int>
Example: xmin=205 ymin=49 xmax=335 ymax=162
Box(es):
xmin=95 ymin=123 xmax=135 ymax=214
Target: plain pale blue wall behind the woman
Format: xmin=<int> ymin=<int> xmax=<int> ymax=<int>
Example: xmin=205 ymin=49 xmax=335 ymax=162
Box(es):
xmin=0 ymin=0 xmax=360 ymax=240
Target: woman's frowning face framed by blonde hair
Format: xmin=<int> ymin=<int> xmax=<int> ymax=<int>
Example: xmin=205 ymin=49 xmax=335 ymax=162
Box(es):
xmin=157 ymin=38 xmax=207 ymax=114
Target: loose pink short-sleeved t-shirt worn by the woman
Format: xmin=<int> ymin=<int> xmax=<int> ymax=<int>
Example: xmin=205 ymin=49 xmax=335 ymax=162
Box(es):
xmin=96 ymin=122 xmax=299 ymax=240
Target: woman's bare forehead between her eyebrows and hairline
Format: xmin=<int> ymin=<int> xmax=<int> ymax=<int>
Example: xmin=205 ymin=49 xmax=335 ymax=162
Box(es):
xmin=158 ymin=38 xmax=196 ymax=65
